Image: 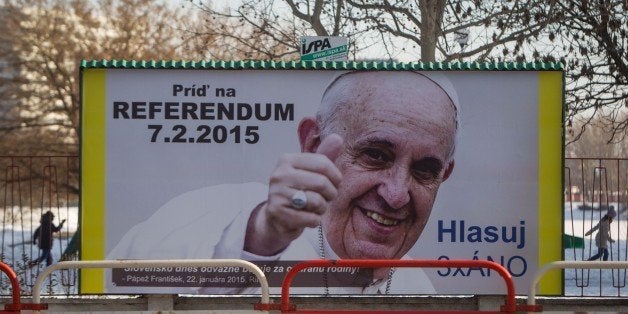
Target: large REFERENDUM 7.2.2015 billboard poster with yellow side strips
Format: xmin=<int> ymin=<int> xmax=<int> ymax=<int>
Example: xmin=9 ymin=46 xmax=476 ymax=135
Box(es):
xmin=81 ymin=62 xmax=563 ymax=294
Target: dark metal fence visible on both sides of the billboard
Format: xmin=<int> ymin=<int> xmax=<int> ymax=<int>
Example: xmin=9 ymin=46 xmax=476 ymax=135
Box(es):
xmin=0 ymin=156 xmax=628 ymax=296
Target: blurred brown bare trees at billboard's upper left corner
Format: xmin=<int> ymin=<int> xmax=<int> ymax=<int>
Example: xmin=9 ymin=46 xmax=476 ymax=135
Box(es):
xmin=0 ymin=0 xmax=204 ymax=155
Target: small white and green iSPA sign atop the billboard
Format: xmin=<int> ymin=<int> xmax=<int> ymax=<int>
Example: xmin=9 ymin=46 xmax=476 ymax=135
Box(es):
xmin=301 ymin=36 xmax=349 ymax=61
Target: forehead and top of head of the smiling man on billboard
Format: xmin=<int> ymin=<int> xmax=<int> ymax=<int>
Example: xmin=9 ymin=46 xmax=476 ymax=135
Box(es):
xmin=319 ymin=71 xmax=458 ymax=156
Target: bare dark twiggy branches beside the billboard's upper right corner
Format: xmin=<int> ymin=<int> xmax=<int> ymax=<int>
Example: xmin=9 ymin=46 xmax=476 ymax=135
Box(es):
xmin=548 ymin=0 xmax=628 ymax=143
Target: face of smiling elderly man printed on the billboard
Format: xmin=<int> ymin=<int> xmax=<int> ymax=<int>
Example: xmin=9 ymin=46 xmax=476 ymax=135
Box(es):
xmin=323 ymin=72 xmax=456 ymax=259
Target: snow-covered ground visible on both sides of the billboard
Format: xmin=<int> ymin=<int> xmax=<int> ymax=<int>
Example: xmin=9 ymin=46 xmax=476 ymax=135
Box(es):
xmin=0 ymin=203 xmax=628 ymax=296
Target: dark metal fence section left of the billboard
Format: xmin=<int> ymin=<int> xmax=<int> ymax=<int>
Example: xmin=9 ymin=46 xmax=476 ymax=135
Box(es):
xmin=0 ymin=156 xmax=79 ymax=295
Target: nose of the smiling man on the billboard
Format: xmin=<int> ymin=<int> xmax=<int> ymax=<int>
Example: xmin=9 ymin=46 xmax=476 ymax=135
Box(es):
xmin=377 ymin=167 xmax=410 ymax=209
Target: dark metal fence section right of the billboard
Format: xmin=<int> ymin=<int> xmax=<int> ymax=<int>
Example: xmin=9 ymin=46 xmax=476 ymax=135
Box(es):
xmin=564 ymin=158 xmax=628 ymax=296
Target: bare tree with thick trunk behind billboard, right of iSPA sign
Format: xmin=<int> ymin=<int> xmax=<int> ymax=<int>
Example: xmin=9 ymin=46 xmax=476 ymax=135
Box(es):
xmin=347 ymin=0 xmax=558 ymax=61
